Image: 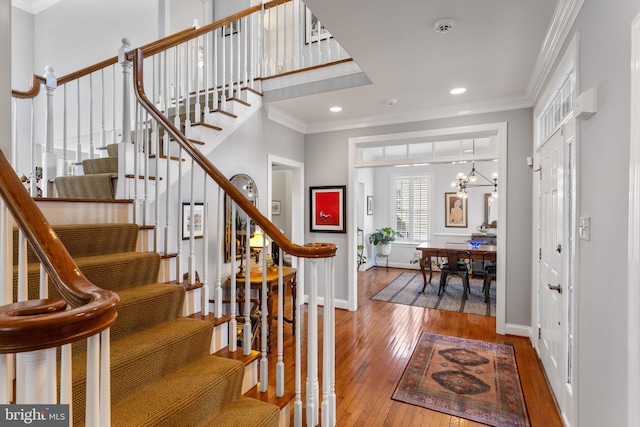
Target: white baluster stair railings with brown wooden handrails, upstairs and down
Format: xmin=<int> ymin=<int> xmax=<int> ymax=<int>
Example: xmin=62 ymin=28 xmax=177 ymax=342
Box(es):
xmin=5 ymin=0 xmax=345 ymax=425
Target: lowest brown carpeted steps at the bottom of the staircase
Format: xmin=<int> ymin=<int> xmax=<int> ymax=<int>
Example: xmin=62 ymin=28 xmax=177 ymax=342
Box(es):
xmin=111 ymin=356 xmax=279 ymax=427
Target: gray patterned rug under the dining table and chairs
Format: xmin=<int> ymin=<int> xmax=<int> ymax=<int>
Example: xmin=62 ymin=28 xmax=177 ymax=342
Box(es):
xmin=371 ymin=272 xmax=496 ymax=317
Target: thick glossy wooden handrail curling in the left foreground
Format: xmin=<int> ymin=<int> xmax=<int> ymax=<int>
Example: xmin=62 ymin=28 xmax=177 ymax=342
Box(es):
xmin=0 ymin=150 xmax=119 ymax=354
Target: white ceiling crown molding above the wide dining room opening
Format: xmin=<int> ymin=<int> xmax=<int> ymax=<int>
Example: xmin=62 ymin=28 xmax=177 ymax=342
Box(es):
xmin=305 ymin=95 xmax=533 ymax=134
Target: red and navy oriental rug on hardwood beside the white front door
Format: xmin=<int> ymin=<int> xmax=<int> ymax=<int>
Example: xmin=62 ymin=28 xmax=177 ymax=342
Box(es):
xmin=392 ymin=332 xmax=530 ymax=427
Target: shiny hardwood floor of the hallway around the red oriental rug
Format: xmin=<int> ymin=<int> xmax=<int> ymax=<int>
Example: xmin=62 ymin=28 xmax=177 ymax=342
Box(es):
xmin=269 ymin=268 xmax=562 ymax=427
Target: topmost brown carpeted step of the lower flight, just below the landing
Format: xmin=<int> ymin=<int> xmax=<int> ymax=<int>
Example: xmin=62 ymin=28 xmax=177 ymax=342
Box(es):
xmin=13 ymin=223 xmax=139 ymax=264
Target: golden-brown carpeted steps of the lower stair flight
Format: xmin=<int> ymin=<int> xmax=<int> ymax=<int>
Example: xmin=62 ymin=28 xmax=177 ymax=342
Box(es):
xmin=14 ymin=223 xmax=279 ymax=427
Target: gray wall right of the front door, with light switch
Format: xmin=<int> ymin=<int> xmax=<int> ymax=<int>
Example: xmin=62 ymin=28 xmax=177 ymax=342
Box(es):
xmin=548 ymin=0 xmax=640 ymax=427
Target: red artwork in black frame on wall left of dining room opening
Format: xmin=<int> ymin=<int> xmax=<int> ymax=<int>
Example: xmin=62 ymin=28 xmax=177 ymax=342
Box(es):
xmin=309 ymin=185 xmax=347 ymax=233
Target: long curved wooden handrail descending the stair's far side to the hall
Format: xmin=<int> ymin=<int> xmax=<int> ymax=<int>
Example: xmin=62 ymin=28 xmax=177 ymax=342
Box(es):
xmin=133 ymin=49 xmax=337 ymax=258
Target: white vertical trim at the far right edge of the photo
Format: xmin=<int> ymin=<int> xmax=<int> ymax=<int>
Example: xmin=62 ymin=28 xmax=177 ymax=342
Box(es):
xmin=627 ymin=15 xmax=640 ymax=425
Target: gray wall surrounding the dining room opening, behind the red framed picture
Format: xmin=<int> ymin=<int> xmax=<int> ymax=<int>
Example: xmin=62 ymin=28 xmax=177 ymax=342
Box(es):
xmin=305 ymin=108 xmax=533 ymax=327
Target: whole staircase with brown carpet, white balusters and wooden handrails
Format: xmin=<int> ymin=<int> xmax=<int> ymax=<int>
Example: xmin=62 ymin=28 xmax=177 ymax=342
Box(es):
xmin=0 ymin=0 xmax=336 ymax=427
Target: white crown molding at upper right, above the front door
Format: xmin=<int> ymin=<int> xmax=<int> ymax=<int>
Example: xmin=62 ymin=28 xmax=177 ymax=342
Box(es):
xmin=527 ymin=0 xmax=584 ymax=103
